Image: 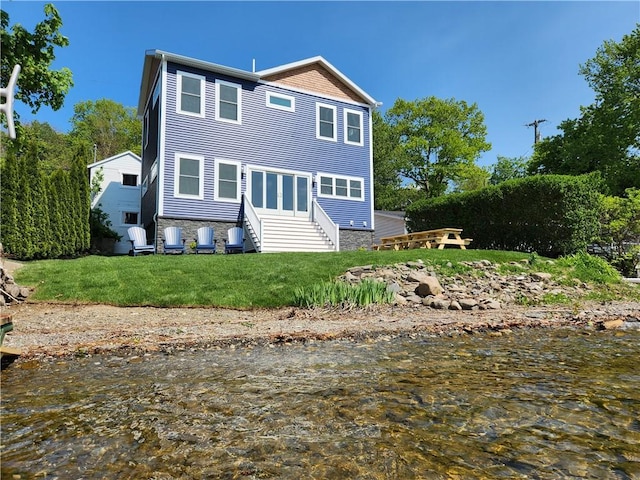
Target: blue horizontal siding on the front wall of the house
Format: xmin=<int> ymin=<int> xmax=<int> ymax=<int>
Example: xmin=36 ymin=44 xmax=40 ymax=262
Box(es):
xmin=163 ymin=64 xmax=372 ymax=228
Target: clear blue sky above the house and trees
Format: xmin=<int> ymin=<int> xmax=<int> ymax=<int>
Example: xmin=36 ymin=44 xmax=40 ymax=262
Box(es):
xmin=2 ymin=0 xmax=640 ymax=165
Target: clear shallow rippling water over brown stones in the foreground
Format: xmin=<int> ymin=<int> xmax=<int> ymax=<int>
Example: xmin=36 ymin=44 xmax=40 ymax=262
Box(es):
xmin=1 ymin=330 xmax=640 ymax=480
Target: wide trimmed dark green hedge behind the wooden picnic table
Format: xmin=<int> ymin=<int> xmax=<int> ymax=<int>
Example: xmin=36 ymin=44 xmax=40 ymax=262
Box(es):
xmin=407 ymin=175 xmax=601 ymax=257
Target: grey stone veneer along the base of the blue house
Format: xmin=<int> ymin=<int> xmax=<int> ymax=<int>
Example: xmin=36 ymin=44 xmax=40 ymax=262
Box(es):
xmin=156 ymin=217 xmax=374 ymax=253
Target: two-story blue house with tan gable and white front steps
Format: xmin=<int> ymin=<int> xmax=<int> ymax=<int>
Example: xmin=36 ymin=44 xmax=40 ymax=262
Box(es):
xmin=138 ymin=50 xmax=378 ymax=252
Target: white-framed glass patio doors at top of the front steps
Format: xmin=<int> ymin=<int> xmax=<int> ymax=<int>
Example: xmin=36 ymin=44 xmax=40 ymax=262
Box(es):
xmin=249 ymin=169 xmax=311 ymax=217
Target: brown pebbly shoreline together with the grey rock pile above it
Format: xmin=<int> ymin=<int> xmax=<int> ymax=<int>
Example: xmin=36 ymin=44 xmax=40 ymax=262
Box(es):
xmin=3 ymin=262 xmax=640 ymax=361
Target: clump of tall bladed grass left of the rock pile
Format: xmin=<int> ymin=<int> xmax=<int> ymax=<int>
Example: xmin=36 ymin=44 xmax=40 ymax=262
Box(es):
xmin=294 ymin=279 xmax=394 ymax=308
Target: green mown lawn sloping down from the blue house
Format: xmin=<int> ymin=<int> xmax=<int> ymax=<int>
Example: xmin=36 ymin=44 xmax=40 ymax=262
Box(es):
xmin=15 ymin=249 xmax=639 ymax=309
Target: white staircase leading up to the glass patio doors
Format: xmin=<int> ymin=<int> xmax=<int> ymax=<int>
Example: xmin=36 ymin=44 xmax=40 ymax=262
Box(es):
xmin=245 ymin=216 xmax=336 ymax=253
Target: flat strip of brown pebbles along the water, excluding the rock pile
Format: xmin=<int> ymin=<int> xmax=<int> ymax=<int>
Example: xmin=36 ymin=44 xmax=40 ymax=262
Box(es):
xmin=5 ymin=302 xmax=640 ymax=361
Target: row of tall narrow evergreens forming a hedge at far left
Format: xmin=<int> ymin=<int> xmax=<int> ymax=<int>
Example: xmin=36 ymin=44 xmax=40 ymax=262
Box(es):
xmin=0 ymin=143 xmax=90 ymax=260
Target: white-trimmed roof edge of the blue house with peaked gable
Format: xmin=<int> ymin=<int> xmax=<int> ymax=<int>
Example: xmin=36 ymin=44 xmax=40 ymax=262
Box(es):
xmin=138 ymin=50 xmax=380 ymax=115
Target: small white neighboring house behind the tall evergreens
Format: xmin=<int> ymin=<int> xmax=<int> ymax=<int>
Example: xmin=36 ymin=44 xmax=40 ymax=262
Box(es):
xmin=87 ymin=151 xmax=142 ymax=254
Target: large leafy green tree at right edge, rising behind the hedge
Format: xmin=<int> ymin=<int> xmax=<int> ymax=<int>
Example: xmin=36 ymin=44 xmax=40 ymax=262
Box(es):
xmin=529 ymin=25 xmax=640 ymax=196
